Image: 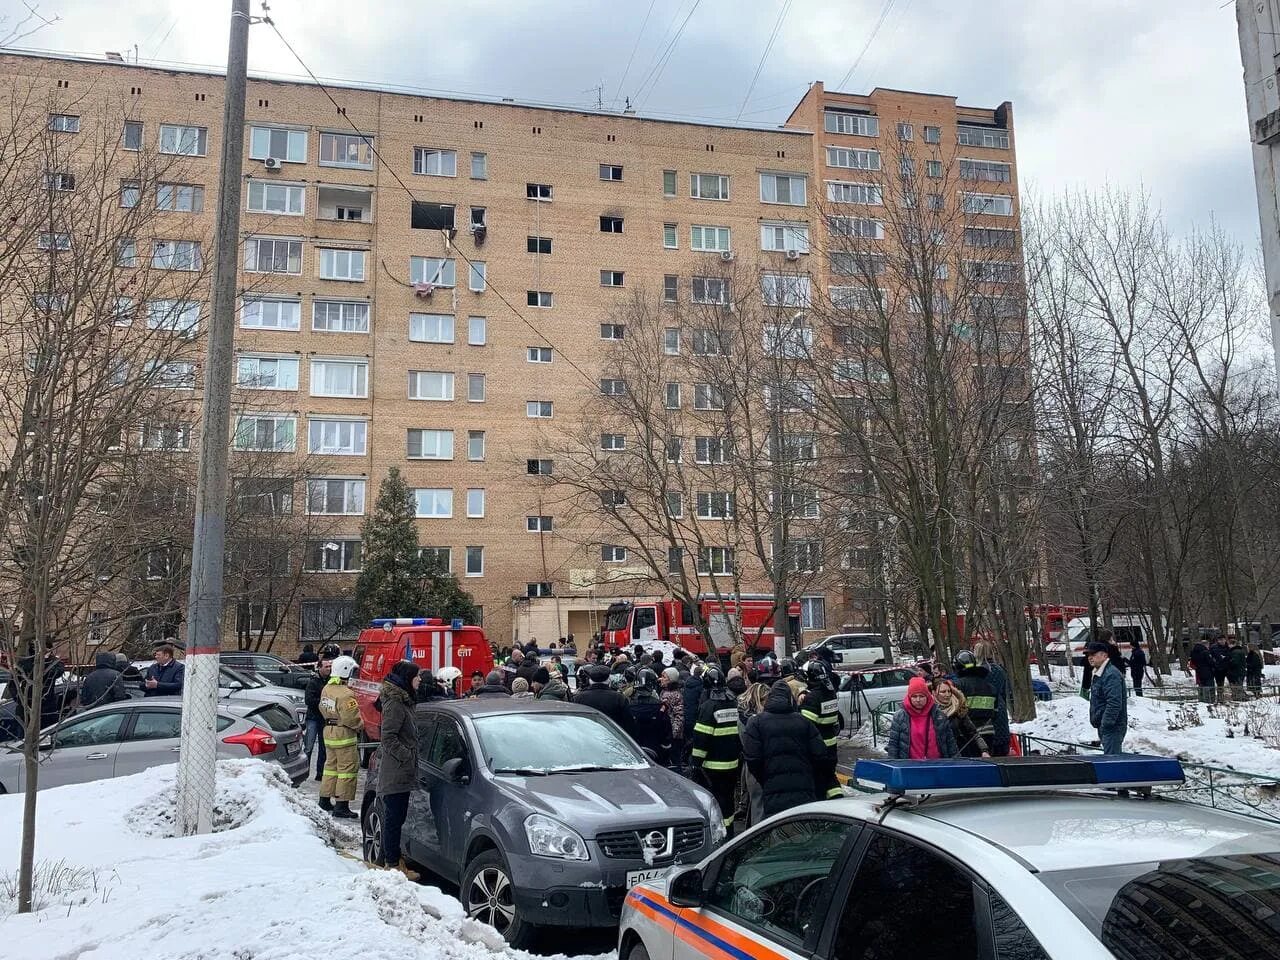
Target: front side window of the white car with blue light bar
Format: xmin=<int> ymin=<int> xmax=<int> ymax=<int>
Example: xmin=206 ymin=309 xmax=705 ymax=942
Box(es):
xmin=707 ymin=817 xmax=849 ymax=960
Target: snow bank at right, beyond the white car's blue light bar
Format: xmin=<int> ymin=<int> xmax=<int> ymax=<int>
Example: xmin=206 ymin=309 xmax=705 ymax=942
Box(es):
xmin=1012 ymin=696 xmax=1280 ymax=777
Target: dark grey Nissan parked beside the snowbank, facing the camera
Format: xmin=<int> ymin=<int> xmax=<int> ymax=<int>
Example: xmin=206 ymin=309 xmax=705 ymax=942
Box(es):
xmin=361 ymin=698 xmax=724 ymax=946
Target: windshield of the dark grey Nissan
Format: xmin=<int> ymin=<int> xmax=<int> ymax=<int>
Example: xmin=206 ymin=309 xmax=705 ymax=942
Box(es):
xmin=475 ymin=712 xmax=646 ymax=774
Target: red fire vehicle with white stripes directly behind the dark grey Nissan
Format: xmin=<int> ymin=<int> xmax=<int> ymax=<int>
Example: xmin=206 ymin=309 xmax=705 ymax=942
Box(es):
xmin=351 ymin=617 xmax=493 ymax=740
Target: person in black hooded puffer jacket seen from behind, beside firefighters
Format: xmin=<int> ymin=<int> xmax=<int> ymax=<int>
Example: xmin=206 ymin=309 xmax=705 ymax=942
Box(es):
xmin=742 ymin=680 xmax=827 ymax=817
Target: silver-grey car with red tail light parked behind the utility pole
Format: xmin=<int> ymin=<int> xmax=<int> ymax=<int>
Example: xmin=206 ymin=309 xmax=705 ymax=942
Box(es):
xmin=0 ymin=696 xmax=307 ymax=794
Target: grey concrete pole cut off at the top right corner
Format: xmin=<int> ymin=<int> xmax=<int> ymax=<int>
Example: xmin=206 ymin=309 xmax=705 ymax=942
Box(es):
xmin=1235 ymin=0 xmax=1280 ymax=384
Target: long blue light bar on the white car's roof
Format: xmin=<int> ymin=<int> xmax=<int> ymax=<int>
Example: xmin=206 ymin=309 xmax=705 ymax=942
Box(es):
xmin=854 ymin=754 xmax=1185 ymax=796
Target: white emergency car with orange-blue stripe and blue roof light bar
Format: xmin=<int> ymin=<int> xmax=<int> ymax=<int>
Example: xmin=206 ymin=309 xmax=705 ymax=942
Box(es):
xmin=618 ymin=755 xmax=1280 ymax=960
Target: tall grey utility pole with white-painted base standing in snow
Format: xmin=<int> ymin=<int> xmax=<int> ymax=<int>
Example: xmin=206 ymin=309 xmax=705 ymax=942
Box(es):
xmin=177 ymin=0 xmax=251 ymax=836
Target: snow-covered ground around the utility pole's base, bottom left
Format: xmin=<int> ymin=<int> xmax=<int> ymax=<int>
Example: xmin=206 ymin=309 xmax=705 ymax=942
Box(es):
xmin=0 ymin=760 xmax=614 ymax=960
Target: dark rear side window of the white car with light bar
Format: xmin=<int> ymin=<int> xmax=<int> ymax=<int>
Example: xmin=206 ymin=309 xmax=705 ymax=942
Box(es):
xmin=833 ymin=831 xmax=980 ymax=960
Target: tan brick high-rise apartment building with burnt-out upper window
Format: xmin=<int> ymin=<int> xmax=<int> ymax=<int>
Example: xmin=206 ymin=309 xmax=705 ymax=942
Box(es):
xmin=0 ymin=55 xmax=1016 ymax=649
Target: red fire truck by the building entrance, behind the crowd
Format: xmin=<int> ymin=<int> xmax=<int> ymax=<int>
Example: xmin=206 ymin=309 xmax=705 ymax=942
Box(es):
xmin=600 ymin=594 xmax=800 ymax=657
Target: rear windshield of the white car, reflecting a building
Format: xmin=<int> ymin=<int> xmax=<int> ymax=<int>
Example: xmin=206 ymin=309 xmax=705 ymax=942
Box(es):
xmin=1038 ymin=852 xmax=1280 ymax=960
